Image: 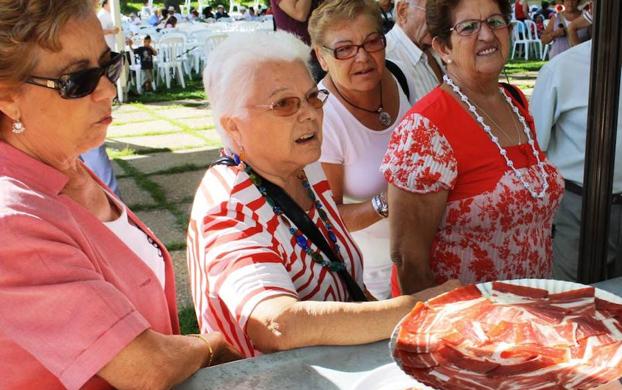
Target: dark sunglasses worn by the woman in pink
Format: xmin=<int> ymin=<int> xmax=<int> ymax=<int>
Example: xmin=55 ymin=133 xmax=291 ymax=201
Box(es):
xmin=26 ymin=53 xmax=123 ymax=99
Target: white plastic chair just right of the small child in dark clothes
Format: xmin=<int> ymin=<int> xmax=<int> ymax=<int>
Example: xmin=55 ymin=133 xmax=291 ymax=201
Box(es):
xmin=157 ymin=32 xmax=186 ymax=88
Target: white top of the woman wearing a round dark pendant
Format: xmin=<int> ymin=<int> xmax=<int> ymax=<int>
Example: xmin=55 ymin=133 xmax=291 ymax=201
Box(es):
xmin=318 ymin=77 xmax=410 ymax=299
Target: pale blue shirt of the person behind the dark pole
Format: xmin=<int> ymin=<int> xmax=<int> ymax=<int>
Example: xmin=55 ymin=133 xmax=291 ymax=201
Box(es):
xmin=530 ymin=40 xmax=622 ymax=193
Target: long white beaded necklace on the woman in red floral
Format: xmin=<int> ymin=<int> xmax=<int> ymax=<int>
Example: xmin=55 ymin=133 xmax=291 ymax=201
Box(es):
xmin=443 ymin=74 xmax=549 ymax=199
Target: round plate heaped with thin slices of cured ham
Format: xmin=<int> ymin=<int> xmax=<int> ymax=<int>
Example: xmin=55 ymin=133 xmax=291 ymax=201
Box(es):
xmin=389 ymin=279 xmax=622 ymax=390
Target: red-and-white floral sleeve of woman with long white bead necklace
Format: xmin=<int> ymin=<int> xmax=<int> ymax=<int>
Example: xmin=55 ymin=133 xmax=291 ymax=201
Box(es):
xmin=380 ymin=112 xmax=458 ymax=194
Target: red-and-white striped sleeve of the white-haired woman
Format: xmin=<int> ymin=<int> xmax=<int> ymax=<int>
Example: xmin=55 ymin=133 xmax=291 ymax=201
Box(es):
xmin=202 ymin=199 xmax=298 ymax=329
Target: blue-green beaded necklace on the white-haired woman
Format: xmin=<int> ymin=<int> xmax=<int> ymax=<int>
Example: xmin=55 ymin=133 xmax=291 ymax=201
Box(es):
xmin=244 ymin=164 xmax=346 ymax=272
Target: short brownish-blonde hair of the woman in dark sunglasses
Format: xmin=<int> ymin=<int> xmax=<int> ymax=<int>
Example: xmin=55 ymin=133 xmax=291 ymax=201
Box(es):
xmin=0 ymin=0 xmax=94 ymax=91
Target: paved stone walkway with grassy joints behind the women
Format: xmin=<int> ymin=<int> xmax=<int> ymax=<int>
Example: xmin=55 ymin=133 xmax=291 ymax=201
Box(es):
xmin=106 ymin=72 xmax=537 ymax=310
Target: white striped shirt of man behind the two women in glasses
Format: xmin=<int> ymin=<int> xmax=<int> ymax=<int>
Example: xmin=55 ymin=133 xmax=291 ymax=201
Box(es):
xmin=386 ymin=24 xmax=442 ymax=104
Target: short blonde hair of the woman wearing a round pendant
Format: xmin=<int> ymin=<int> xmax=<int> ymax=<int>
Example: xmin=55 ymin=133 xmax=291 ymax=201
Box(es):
xmin=309 ymin=0 xmax=382 ymax=46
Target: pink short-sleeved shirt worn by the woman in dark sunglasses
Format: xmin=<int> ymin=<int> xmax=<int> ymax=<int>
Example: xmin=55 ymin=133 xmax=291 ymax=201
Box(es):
xmin=0 ymin=141 xmax=179 ymax=389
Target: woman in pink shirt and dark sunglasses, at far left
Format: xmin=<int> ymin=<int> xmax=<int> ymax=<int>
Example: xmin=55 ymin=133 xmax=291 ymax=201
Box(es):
xmin=0 ymin=0 xmax=239 ymax=389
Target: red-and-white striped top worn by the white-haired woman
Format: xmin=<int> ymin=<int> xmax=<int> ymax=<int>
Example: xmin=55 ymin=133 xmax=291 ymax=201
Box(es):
xmin=187 ymin=163 xmax=363 ymax=357
